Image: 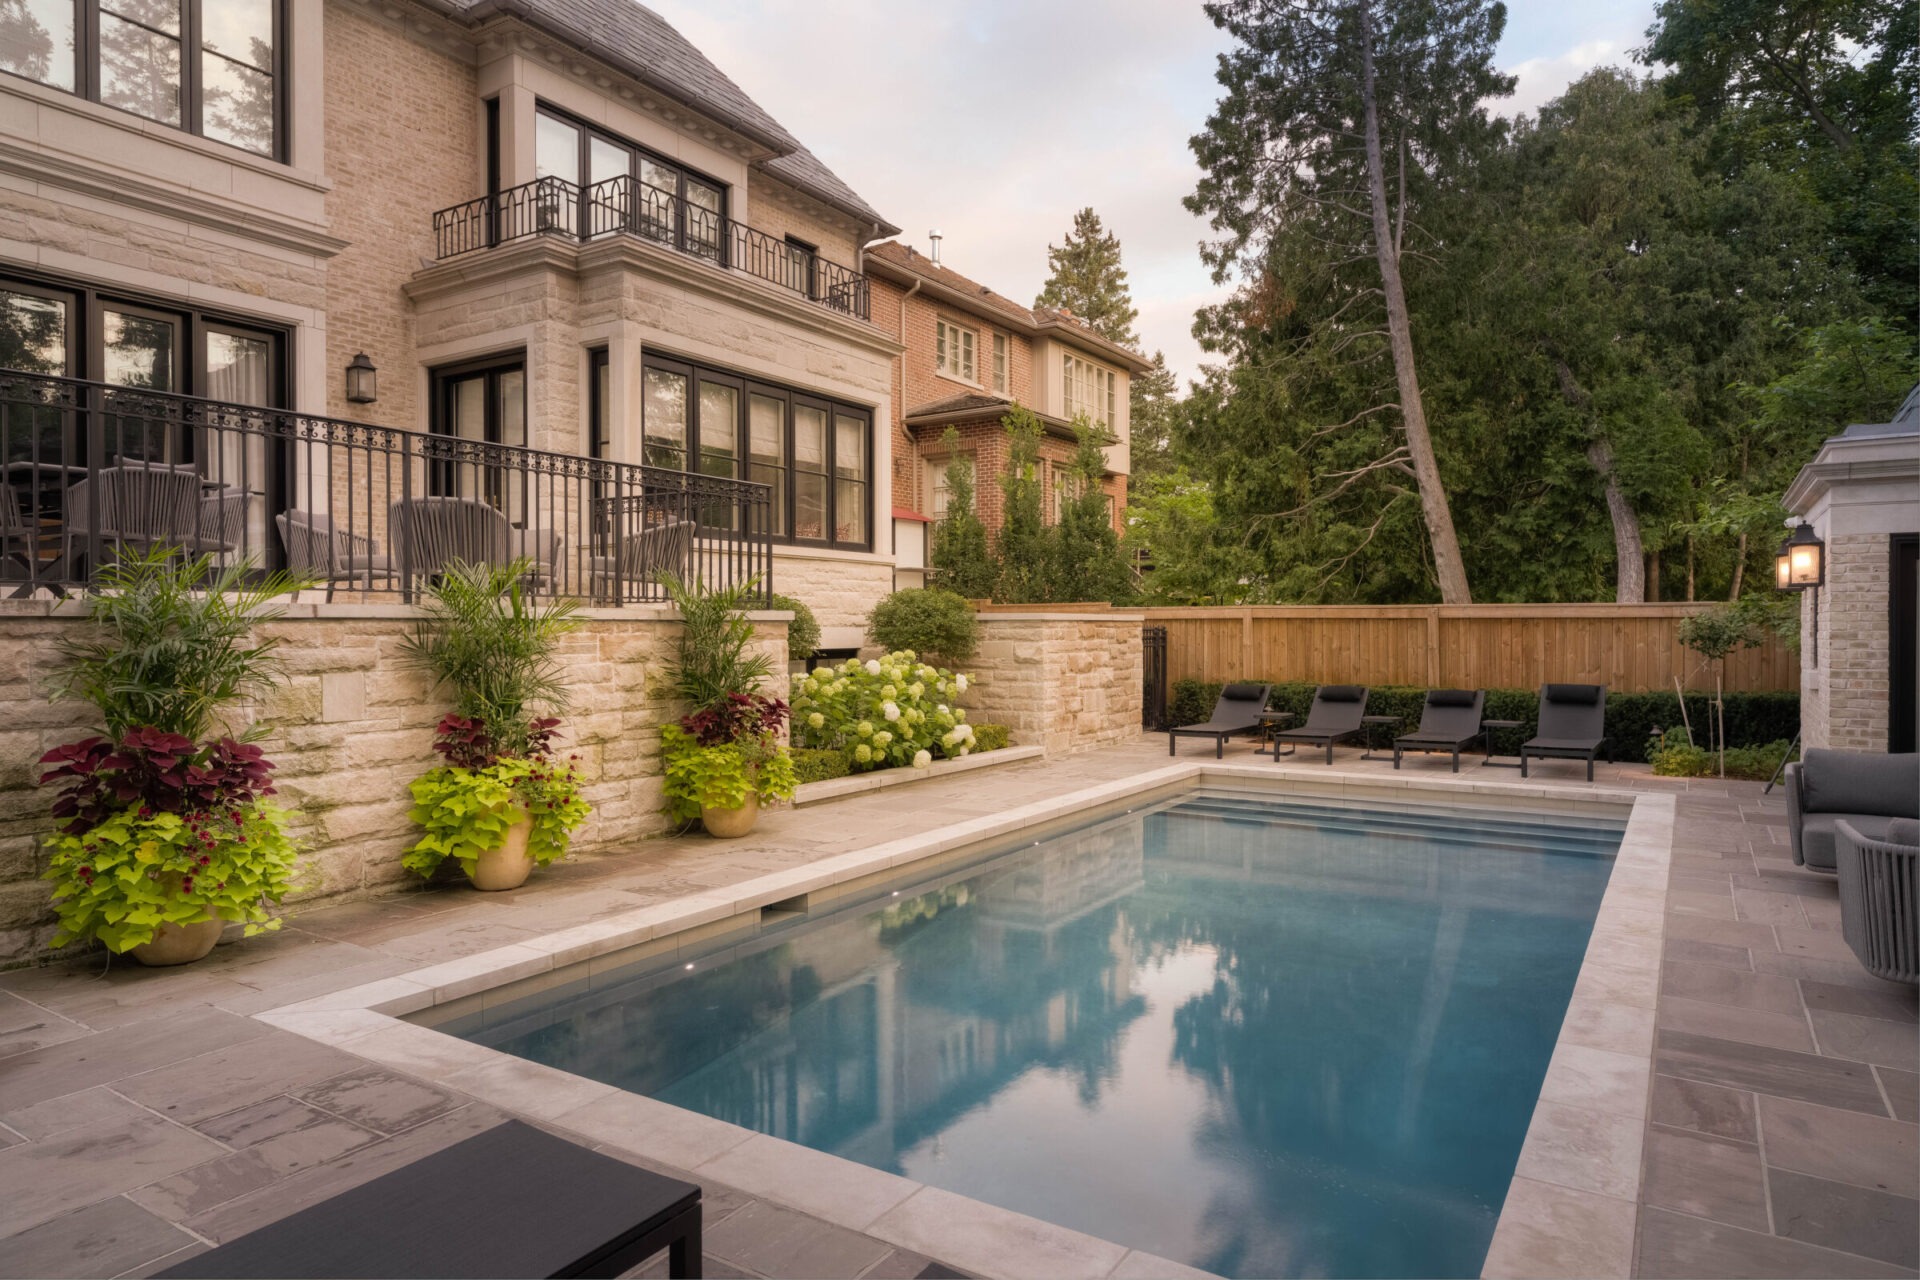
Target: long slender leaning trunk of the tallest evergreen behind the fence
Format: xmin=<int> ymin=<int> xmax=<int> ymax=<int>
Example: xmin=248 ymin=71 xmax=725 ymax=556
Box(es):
xmin=1359 ymin=0 xmax=1473 ymax=604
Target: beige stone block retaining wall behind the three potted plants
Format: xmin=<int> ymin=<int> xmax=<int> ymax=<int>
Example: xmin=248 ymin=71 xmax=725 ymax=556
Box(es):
xmin=0 ymin=603 xmax=787 ymax=963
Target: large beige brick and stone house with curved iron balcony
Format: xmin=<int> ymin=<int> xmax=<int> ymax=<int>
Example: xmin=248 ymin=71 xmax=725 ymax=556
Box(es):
xmin=0 ymin=0 xmax=906 ymax=645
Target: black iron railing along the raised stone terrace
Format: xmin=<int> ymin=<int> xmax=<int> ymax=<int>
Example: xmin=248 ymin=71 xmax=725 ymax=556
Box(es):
xmin=0 ymin=368 xmax=774 ymax=604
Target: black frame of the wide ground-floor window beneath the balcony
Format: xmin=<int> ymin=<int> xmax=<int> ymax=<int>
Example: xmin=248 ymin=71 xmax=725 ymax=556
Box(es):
xmin=639 ymin=351 xmax=877 ymax=551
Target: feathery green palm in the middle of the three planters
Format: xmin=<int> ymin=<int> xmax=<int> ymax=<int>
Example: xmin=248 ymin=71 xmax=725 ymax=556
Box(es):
xmin=401 ymin=560 xmax=580 ymax=756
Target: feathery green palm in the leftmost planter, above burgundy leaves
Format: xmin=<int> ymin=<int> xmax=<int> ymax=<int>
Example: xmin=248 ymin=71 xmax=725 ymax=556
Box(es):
xmin=54 ymin=547 xmax=311 ymax=743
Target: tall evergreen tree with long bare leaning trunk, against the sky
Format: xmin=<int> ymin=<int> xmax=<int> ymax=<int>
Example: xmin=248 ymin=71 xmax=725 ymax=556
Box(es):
xmin=1187 ymin=0 xmax=1513 ymax=603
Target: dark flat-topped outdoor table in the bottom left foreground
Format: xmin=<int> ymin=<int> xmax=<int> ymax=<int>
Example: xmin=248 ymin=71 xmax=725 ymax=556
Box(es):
xmin=159 ymin=1121 xmax=701 ymax=1280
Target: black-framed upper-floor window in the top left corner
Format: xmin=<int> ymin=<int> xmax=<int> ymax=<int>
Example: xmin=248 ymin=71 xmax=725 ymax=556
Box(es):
xmin=0 ymin=0 xmax=286 ymax=159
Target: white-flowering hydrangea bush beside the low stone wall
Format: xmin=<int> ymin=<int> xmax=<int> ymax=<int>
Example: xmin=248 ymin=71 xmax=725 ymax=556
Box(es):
xmin=793 ymin=649 xmax=973 ymax=773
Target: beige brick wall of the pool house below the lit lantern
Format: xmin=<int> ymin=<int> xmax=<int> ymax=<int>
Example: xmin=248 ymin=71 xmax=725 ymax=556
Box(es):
xmin=1801 ymin=533 xmax=1893 ymax=750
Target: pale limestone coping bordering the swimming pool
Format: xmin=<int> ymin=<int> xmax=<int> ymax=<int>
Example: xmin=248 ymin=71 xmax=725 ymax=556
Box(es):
xmin=253 ymin=762 xmax=1676 ymax=1280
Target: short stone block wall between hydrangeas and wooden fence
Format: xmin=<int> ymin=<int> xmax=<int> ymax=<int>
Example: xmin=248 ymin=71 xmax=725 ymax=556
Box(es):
xmin=966 ymin=612 xmax=1142 ymax=754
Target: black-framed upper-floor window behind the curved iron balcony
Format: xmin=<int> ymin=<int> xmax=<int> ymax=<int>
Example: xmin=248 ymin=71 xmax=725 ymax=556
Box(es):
xmin=533 ymin=104 xmax=728 ymax=265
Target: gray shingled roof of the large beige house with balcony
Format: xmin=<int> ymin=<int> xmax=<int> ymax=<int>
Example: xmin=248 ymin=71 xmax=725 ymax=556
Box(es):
xmin=424 ymin=0 xmax=900 ymax=234
